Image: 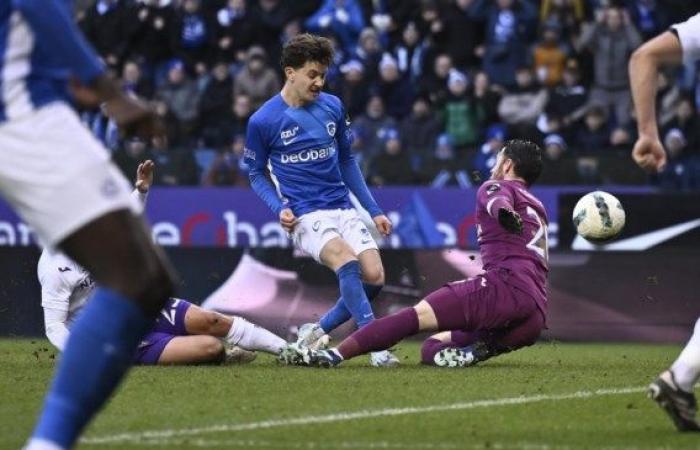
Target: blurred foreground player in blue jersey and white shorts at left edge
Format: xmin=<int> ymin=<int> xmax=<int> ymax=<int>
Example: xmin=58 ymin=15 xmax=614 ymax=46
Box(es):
xmin=0 ymin=0 xmax=173 ymax=450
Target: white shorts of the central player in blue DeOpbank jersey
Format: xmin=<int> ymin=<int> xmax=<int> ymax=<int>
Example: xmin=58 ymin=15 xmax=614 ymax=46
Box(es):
xmin=292 ymin=209 xmax=377 ymax=262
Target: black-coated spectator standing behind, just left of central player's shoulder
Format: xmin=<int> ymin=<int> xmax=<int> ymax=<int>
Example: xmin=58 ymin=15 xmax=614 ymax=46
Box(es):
xmin=199 ymin=62 xmax=233 ymax=148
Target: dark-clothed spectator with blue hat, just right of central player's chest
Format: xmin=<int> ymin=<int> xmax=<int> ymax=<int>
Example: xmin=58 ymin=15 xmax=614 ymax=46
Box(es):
xmin=369 ymin=128 xmax=416 ymax=186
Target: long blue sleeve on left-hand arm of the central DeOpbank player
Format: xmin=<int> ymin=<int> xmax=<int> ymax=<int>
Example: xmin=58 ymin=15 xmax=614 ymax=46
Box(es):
xmin=243 ymin=118 xmax=284 ymax=216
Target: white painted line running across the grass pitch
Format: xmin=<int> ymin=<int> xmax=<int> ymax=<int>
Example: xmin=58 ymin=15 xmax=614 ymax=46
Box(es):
xmin=81 ymin=387 xmax=645 ymax=444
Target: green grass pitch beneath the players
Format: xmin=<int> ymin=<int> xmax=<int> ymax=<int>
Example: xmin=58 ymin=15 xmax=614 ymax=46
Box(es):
xmin=0 ymin=340 xmax=700 ymax=450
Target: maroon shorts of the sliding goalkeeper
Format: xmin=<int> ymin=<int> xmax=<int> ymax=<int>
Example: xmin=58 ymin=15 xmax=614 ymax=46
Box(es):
xmin=425 ymin=269 xmax=545 ymax=342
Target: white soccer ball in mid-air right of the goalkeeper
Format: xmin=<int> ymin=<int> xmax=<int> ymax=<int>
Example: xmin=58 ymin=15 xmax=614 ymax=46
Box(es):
xmin=573 ymin=191 xmax=625 ymax=243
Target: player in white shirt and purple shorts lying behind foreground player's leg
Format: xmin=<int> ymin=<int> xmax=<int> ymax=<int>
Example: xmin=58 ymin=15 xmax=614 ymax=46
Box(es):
xmin=38 ymin=161 xmax=285 ymax=364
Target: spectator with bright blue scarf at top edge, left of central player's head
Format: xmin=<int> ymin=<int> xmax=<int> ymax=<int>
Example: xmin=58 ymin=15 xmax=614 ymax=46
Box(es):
xmin=172 ymin=0 xmax=215 ymax=76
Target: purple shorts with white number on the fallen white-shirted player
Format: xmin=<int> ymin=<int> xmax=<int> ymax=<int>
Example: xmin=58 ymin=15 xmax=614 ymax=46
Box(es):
xmin=134 ymin=298 xmax=192 ymax=365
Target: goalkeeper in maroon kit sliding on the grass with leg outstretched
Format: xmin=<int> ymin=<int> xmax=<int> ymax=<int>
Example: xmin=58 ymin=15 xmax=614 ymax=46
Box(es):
xmin=280 ymin=140 xmax=548 ymax=367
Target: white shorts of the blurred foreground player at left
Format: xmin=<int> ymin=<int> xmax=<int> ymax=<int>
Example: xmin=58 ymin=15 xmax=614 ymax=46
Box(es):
xmin=0 ymin=102 xmax=138 ymax=247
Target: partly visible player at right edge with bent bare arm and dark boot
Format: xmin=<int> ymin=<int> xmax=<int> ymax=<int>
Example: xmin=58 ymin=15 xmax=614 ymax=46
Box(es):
xmin=629 ymin=14 xmax=700 ymax=431
